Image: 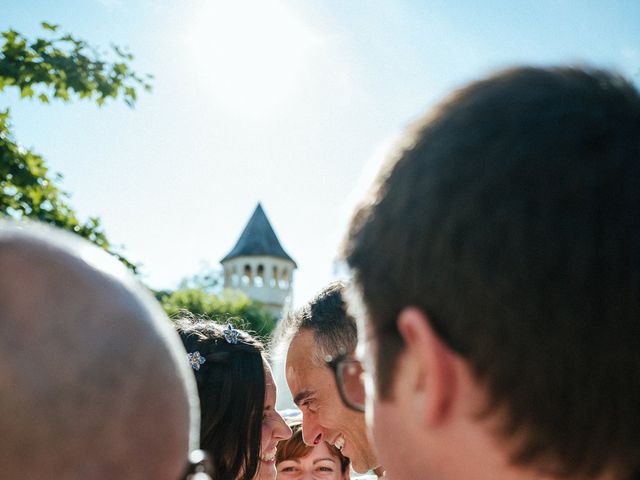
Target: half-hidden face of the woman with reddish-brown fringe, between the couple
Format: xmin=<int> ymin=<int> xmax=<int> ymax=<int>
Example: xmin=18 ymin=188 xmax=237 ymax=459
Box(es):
xmin=278 ymin=442 xmax=349 ymax=480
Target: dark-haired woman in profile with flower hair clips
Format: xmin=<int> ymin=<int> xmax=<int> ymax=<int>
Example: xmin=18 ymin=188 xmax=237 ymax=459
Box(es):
xmin=176 ymin=318 xmax=291 ymax=480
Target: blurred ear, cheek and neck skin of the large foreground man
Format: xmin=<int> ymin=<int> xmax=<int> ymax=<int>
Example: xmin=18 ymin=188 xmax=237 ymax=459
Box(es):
xmin=358 ymin=308 xmax=472 ymax=480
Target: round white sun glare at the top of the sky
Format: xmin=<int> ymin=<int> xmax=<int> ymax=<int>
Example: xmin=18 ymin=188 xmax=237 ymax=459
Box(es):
xmin=187 ymin=0 xmax=318 ymax=116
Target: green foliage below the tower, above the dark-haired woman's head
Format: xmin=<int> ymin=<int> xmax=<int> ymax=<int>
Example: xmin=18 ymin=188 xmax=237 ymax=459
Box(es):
xmin=156 ymin=288 xmax=275 ymax=340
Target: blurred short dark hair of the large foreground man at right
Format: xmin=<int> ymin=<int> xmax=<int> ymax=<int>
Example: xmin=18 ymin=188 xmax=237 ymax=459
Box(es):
xmin=345 ymin=68 xmax=640 ymax=476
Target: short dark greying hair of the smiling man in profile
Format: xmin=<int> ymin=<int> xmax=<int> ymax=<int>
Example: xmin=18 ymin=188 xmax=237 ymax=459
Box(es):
xmin=281 ymin=281 xmax=358 ymax=364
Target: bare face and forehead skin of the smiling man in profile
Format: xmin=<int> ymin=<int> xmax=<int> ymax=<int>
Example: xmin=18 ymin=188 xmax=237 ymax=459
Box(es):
xmin=286 ymin=330 xmax=378 ymax=472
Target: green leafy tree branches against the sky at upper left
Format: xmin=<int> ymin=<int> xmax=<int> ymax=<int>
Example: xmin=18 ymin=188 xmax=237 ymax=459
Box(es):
xmin=0 ymin=22 xmax=151 ymax=272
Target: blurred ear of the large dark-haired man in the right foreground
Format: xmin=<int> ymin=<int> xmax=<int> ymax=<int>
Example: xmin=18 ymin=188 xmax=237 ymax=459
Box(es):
xmin=398 ymin=307 xmax=457 ymax=427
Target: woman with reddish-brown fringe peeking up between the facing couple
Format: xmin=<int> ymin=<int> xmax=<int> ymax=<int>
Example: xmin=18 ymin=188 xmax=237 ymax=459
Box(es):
xmin=276 ymin=422 xmax=349 ymax=480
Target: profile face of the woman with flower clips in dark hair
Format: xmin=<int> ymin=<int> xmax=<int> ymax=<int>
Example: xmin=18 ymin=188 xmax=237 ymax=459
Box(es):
xmin=256 ymin=365 xmax=291 ymax=480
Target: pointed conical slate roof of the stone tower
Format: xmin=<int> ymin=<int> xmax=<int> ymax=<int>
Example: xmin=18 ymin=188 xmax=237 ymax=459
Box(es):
xmin=220 ymin=203 xmax=297 ymax=268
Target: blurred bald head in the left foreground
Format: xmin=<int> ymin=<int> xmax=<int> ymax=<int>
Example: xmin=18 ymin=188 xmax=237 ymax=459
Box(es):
xmin=0 ymin=224 xmax=198 ymax=480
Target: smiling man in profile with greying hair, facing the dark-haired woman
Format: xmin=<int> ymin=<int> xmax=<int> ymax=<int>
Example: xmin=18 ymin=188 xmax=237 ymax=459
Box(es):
xmin=283 ymin=283 xmax=382 ymax=475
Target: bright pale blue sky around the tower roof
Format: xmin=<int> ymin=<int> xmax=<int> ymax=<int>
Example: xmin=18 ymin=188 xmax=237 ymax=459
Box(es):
xmin=0 ymin=0 xmax=640 ymax=305
